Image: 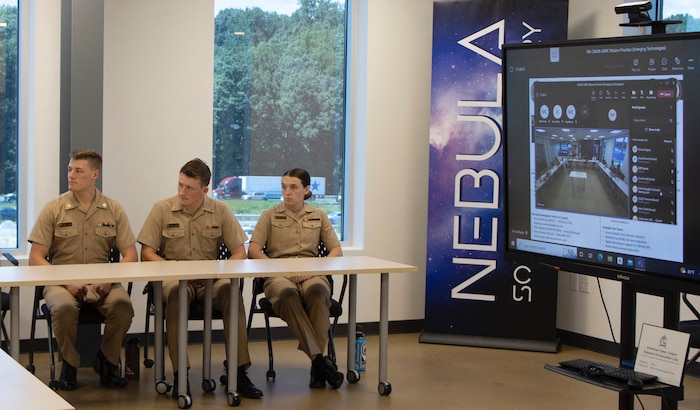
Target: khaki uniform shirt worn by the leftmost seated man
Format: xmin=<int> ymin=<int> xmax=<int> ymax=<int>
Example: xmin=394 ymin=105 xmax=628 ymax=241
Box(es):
xmin=29 ymin=190 xmax=136 ymax=265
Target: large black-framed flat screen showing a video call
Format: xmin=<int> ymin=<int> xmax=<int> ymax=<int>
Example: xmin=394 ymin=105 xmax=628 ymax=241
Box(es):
xmin=503 ymin=33 xmax=700 ymax=289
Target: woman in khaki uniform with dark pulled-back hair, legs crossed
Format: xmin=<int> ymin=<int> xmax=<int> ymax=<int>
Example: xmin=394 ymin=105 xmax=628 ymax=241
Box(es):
xmin=248 ymin=168 xmax=343 ymax=389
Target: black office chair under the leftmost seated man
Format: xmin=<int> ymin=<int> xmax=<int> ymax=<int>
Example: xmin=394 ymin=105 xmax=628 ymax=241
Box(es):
xmin=25 ymin=247 xmax=133 ymax=390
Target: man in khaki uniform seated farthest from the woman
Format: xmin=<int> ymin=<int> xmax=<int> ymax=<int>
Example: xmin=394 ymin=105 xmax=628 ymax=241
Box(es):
xmin=29 ymin=150 xmax=138 ymax=390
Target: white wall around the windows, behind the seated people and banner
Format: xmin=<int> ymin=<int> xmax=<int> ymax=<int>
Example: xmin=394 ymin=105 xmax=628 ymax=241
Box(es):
xmin=10 ymin=0 xmax=688 ymax=348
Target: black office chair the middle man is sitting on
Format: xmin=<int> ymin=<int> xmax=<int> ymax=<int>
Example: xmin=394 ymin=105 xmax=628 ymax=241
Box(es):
xmin=143 ymin=243 xmax=235 ymax=393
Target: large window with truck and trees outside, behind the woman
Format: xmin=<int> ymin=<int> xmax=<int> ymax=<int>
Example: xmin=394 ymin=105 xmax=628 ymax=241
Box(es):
xmin=212 ymin=0 xmax=347 ymax=238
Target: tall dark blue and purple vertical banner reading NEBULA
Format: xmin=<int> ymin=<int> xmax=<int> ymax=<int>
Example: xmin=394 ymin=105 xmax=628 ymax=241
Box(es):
xmin=420 ymin=0 xmax=568 ymax=351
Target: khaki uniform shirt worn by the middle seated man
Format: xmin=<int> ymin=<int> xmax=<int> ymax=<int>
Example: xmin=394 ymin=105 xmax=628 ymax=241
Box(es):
xmin=138 ymin=196 xmax=248 ymax=260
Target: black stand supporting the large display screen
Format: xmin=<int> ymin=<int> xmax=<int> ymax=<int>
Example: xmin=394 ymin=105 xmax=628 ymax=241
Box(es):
xmin=619 ymin=282 xmax=683 ymax=410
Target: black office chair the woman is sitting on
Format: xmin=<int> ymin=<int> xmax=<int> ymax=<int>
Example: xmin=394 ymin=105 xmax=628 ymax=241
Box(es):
xmin=248 ymin=243 xmax=348 ymax=381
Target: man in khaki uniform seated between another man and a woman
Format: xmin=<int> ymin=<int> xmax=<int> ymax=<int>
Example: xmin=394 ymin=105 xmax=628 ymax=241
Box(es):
xmin=138 ymin=158 xmax=263 ymax=399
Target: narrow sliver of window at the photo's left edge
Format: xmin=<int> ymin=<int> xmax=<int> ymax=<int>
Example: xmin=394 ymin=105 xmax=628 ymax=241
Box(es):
xmin=0 ymin=0 xmax=19 ymax=249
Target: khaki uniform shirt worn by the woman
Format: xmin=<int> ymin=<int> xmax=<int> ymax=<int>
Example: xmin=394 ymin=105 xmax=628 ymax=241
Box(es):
xmin=250 ymin=203 xmax=340 ymax=258
